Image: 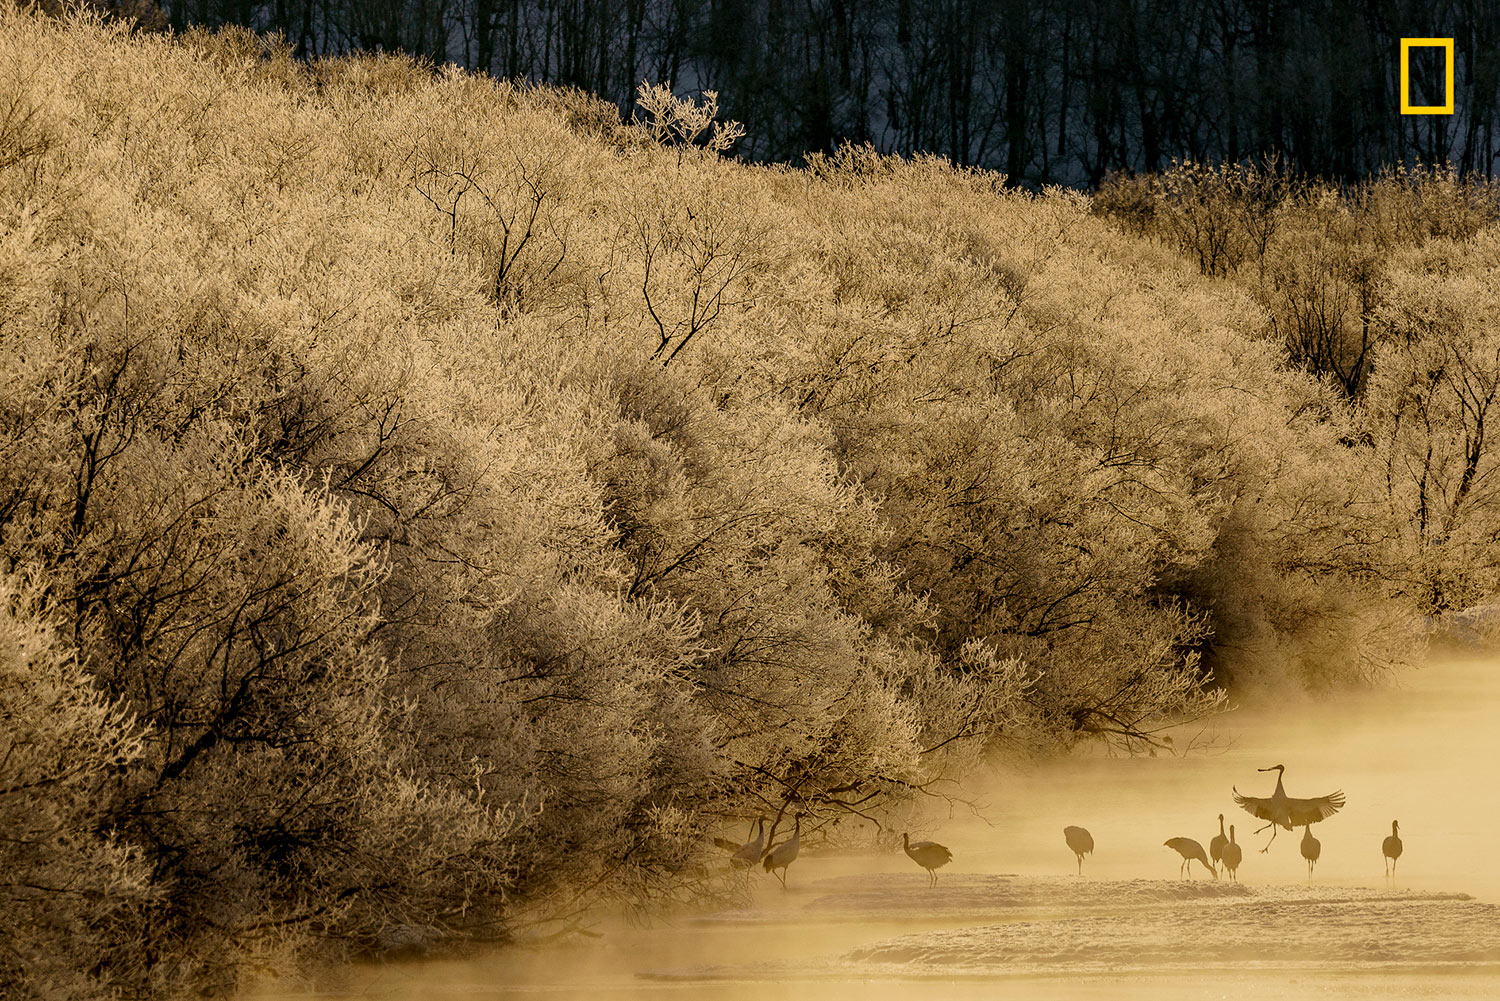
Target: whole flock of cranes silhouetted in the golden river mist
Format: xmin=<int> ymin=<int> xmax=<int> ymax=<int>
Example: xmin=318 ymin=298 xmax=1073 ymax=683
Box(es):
xmin=714 ymin=765 xmax=1401 ymax=890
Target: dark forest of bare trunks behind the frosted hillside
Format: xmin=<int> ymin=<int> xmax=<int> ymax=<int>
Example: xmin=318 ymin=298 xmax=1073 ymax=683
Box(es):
xmin=141 ymin=0 xmax=1500 ymax=186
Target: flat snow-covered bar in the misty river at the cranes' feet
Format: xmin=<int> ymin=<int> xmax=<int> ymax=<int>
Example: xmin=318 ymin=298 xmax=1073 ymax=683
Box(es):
xmin=650 ymin=875 xmax=1500 ymax=980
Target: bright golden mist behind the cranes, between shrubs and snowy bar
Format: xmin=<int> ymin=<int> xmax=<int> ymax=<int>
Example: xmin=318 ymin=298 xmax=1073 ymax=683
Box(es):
xmin=960 ymin=657 xmax=1500 ymax=902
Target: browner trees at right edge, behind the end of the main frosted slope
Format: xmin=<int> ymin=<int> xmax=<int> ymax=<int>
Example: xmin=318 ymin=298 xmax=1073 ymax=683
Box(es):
xmin=1094 ymin=155 xmax=1500 ymax=630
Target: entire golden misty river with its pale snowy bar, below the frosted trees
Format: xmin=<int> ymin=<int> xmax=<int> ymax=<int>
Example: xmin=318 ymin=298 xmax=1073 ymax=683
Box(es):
xmin=257 ymin=656 xmax=1500 ymax=1001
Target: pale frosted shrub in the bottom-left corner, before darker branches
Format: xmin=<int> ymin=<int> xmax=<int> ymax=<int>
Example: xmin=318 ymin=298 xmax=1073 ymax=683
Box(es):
xmin=0 ymin=573 xmax=150 ymax=1001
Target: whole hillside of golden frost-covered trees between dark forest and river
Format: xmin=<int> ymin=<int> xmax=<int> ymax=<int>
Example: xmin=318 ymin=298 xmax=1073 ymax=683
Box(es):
xmin=0 ymin=6 xmax=1500 ymax=999
